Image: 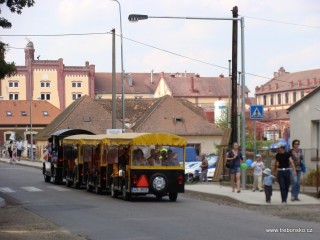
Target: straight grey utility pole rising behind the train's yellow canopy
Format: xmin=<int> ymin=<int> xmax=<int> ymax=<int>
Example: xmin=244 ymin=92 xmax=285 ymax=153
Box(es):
xmin=111 ymin=28 xmax=117 ymax=129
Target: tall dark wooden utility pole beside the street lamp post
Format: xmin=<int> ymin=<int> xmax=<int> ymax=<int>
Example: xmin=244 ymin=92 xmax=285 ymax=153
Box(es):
xmin=231 ymin=6 xmax=238 ymax=143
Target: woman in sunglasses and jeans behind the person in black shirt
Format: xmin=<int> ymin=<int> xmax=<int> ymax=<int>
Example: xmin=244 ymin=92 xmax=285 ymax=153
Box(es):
xmin=289 ymin=139 xmax=306 ymax=201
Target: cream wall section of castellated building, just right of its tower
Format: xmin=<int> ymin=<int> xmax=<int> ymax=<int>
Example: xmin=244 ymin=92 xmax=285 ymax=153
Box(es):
xmin=33 ymin=69 xmax=60 ymax=109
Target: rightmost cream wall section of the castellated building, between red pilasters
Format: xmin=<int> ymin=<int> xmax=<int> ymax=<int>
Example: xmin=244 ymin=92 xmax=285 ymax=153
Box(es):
xmin=65 ymin=75 xmax=89 ymax=107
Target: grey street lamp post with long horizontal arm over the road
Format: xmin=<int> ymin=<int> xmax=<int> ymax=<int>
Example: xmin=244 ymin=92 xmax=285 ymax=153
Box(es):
xmin=128 ymin=14 xmax=246 ymax=188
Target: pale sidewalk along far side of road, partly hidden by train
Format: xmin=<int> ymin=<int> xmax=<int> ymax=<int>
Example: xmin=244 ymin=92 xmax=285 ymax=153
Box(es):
xmin=0 ymin=158 xmax=320 ymax=206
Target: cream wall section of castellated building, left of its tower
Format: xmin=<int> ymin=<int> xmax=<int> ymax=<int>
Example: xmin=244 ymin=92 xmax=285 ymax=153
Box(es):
xmin=0 ymin=74 xmax=27 ymax=100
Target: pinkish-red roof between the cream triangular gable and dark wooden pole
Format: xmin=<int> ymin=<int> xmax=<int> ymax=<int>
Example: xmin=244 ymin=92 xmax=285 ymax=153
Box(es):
xmin=165 ymin=75 xmax=249 ymax=98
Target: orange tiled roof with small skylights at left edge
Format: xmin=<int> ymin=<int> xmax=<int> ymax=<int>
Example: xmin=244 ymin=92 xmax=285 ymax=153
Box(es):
xmin=0 ymin=100 xmax=61 ymax=125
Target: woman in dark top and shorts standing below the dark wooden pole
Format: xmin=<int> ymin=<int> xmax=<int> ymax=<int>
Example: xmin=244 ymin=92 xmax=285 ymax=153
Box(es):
xmin=226 ymin=142 xmax=243 ymax=193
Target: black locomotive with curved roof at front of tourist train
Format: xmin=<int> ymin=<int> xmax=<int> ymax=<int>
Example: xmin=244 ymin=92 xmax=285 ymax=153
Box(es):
xmin=42 ymin=129 xmax=93 ymax=184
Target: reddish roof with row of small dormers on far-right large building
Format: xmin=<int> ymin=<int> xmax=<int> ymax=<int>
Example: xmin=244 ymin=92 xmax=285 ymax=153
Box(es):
xmin=255 ymin=68 xmax=320 ymax=95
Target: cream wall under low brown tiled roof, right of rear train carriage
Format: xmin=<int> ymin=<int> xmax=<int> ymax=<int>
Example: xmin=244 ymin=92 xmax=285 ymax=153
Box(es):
xmin=183 ymin=136 xmax=222 ymax=154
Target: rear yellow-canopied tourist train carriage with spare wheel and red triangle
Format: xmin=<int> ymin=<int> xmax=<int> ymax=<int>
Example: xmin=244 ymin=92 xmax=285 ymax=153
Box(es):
xmin=106 ymin=133 xmax=186 ymax=201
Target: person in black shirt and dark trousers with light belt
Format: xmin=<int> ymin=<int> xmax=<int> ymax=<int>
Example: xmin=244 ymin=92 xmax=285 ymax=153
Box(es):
xmin=274 ymin=145 xmax=297 ymax=204
